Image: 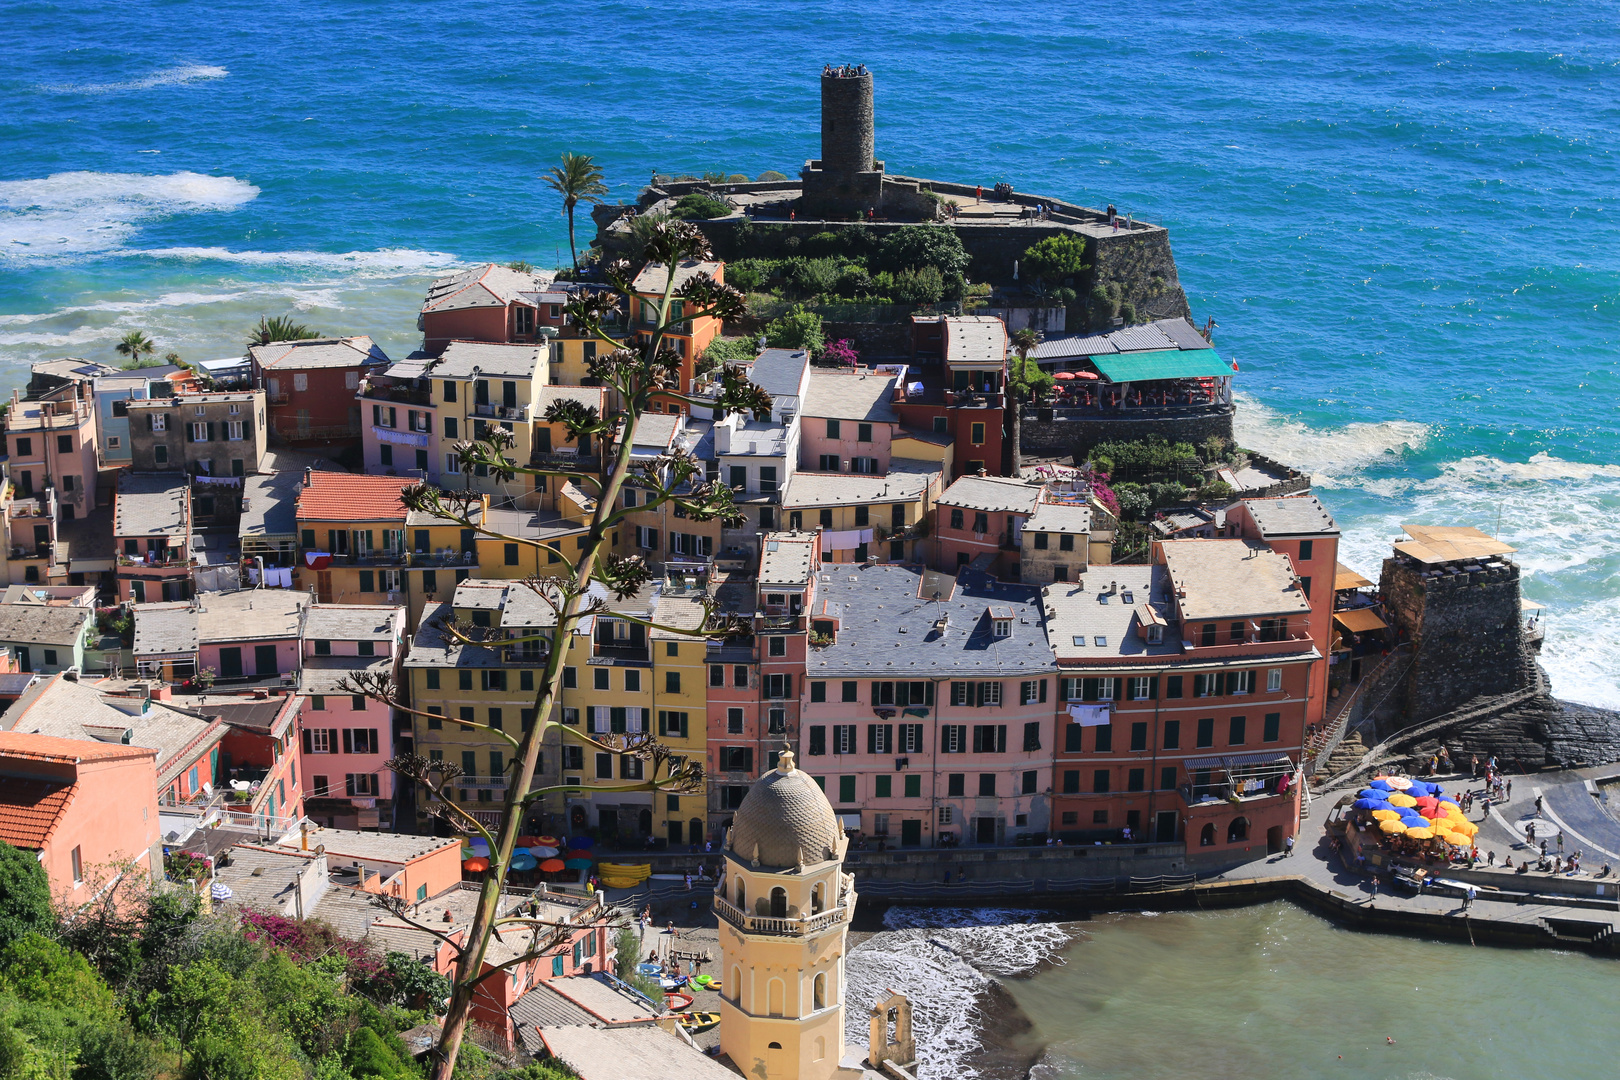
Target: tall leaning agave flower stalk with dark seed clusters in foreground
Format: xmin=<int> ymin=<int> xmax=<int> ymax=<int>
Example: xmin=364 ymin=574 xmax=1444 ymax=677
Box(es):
xmin=343 ymin=222 xmax=771 ymax=1080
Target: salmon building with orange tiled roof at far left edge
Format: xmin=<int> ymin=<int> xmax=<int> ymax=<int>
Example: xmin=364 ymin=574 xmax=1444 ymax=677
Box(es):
xmin=0 ymin=730 xmax=164 ymax=908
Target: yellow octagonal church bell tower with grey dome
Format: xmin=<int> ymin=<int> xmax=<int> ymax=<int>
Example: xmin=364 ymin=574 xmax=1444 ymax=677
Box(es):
xmin=714 ymin=751 xmax=860 ymax=1080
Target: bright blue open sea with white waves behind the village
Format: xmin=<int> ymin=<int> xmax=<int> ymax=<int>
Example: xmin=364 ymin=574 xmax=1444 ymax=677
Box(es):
xmin=0 ymin=0 xmax=1620 ymax=706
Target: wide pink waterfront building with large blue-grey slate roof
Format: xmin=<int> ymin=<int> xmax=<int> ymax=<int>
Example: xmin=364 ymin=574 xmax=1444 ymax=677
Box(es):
xmin=800 ymin=565 xmax=1056 ymax=847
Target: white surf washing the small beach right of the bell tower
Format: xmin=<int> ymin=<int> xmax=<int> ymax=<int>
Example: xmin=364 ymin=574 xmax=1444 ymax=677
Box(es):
xmin=844 ymin=908 xmax=1071 ymax=1080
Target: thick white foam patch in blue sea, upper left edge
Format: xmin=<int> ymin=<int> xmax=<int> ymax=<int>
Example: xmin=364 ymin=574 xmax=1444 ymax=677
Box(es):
xmin=0 ymin=172 xmax=259 ymax=259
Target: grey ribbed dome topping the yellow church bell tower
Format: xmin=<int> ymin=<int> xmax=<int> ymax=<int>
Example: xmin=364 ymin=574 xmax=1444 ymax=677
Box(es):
xmin=727 ymin=753 xmax=844 ymax=866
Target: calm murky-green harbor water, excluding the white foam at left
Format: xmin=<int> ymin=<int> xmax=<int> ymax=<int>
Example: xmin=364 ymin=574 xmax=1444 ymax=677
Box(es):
xmin=1006 ymin=904 xmax=1620 ymax=1080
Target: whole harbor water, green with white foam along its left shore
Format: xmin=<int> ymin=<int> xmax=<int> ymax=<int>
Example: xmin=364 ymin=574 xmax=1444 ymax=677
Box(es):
xmin=847 ymin=904 xmax=1620 ymax=1080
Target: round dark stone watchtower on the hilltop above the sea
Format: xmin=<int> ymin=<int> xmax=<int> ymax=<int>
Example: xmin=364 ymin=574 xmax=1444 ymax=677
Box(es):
xmin=800 ymin=66 xmax=883 ymax=217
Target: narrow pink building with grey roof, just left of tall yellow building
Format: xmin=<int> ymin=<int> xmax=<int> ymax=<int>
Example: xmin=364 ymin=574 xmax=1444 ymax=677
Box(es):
xmin=298 ymin=604 xmax=408 ymax=829
